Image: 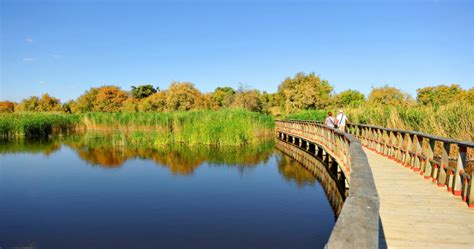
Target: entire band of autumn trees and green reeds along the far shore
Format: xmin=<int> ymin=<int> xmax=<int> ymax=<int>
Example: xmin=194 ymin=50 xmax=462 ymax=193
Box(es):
xmin=0 ymin=73 xmax=474 ymax=141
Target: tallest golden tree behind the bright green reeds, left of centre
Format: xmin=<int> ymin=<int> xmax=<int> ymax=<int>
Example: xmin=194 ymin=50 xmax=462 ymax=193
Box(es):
xmin=167 ymin=82 xmax=206 ymax=111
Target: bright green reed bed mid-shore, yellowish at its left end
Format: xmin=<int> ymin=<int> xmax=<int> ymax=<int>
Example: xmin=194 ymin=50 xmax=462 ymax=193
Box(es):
xmin=84 ymin=110 xmax=274 ymax=145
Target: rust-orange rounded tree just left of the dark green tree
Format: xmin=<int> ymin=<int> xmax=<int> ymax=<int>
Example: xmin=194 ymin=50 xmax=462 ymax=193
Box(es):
xmin=93 ymin=86 xmax=128 ymax=112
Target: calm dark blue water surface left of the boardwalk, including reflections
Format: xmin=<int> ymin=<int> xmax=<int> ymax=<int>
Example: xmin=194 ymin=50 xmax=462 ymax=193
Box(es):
xmin=0 ymin=135 xmax=335 ymax=249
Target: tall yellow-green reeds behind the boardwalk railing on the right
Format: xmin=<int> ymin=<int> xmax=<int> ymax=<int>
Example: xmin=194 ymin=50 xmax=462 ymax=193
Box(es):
xmin=285 ymin=102 xmax=474 ymax=141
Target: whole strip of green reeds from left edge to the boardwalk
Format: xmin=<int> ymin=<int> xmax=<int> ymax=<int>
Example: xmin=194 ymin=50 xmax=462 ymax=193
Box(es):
xmin=0 ymin=110 xmax=274 ymax=145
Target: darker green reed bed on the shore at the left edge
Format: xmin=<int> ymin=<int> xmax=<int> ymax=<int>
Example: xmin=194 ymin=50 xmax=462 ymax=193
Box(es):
xmin=0 ymin=113 xmax=81 ymax=138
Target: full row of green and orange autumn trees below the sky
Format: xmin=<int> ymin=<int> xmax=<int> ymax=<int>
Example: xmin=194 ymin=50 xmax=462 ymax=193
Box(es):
xmin=0 ymin=73 xmax=474 ymax=115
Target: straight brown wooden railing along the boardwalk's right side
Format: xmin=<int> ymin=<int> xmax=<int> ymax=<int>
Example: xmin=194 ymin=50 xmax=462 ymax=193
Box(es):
xmin=346 ymin=124 xmax=474 ymax=207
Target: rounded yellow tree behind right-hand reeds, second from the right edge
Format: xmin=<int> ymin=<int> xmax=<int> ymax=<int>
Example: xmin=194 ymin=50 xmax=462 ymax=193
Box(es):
xmin=367 ymin=85 xmax=412 ymax=106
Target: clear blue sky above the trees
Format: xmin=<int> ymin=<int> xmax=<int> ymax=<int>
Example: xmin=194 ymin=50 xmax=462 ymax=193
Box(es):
xmin=0 ymin=0 xmax=474 ymax=101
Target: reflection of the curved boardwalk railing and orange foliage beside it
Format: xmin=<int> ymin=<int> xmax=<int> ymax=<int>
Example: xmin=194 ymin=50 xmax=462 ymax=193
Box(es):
xmin=276 ymin=140 xmax=345 ymax=217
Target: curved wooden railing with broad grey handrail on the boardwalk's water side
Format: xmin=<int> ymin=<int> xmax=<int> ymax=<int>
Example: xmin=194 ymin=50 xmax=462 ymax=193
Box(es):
xmin=276 ymin=120 xmax=379 ymax=248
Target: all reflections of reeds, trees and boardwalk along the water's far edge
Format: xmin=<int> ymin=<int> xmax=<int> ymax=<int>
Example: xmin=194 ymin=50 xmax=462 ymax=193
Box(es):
xmin=0 ymin=132 xmax=346 ymax=217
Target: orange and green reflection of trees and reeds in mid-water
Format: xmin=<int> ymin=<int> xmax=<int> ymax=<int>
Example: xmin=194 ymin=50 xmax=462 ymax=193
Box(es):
xmin=66 ymin=133 xmax=274 ymax=175
